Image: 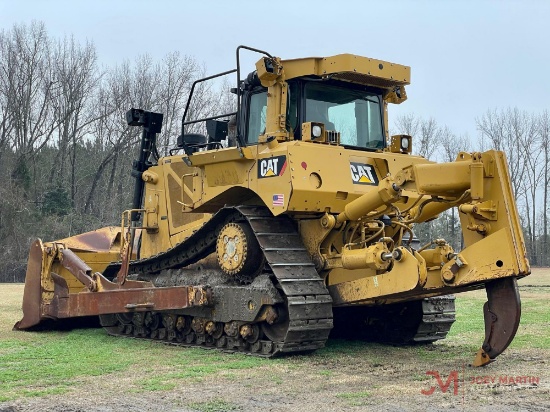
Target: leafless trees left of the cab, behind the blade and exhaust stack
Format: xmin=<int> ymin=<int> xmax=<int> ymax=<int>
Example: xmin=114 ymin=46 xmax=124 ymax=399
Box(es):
xmin=0 ymin=22 xmax=229 ymax=282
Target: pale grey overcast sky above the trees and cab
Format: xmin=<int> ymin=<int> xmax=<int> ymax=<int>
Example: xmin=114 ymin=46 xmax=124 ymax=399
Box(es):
xmin=0 ymin=0 xmax=550 ymax=140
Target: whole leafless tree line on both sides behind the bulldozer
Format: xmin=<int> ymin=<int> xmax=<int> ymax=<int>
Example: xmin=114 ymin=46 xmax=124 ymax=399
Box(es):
xmin=0 ymin=22 xmax=550 ymax=282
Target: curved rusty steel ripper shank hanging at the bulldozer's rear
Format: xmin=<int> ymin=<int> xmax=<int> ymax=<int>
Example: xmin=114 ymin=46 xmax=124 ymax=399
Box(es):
xmin=473 ymin=278 xmax=521 ymax=366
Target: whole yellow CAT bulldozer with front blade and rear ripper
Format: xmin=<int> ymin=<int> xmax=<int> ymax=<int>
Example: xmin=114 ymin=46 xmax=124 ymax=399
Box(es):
xmin=14 ymin=46 xmax=530 ymax=366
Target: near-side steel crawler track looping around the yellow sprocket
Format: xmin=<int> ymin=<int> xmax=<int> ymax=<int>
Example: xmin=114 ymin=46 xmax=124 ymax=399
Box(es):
xmin=101 ymin=207 xmax=332 ymax=356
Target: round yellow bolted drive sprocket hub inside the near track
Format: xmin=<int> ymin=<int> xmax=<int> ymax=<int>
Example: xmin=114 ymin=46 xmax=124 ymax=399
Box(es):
xmin=216 ymin=223 xmax=265 ymax=283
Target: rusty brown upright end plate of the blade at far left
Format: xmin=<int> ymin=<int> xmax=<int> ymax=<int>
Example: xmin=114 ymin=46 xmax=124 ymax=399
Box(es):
xmin=13 ymin=239 xmax=42 ymax=330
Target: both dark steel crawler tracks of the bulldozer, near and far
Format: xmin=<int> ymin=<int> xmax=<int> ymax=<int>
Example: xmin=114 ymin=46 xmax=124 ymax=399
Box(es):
xmin=101 ymin=206 xmax=455 ymax=356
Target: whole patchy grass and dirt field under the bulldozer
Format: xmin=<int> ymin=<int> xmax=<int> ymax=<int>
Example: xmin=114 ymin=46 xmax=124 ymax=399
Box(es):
xmin=0 ymin=268 xmax=550 ymax=412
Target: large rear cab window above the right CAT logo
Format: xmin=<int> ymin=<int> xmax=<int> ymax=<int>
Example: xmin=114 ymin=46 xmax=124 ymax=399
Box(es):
xmin=305 ymin=83 xmax=385 ymax=149
